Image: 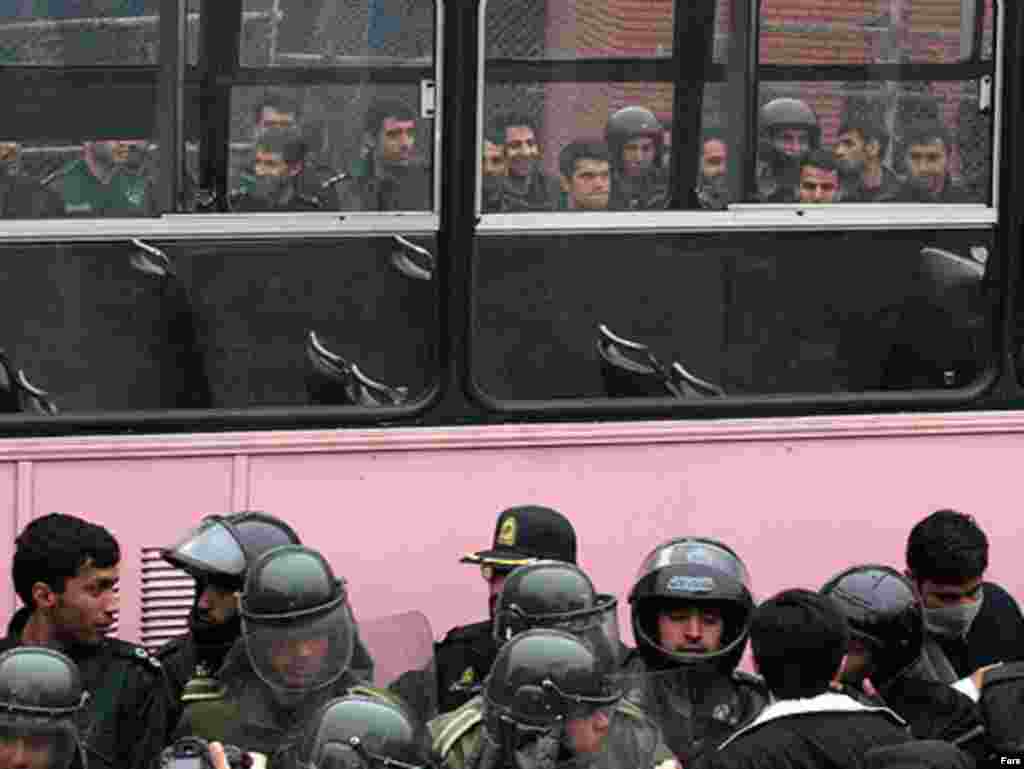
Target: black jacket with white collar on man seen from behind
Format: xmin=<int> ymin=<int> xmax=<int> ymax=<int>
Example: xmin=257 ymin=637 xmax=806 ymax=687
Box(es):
xmin=687 ymin=692 xmax=911 ymax=769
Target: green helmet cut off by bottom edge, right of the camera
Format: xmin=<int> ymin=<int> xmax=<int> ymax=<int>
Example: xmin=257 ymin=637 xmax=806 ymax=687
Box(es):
xmin=298 ymin=694 xmax=430 ymax=769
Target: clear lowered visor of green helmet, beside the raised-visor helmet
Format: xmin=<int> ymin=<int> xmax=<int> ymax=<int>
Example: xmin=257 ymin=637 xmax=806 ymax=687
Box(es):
xmin=242 ymin=602 xmax=354 ymax=695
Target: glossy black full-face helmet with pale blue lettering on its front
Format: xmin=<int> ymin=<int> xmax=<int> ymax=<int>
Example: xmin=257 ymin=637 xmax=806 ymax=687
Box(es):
xmin=630 ymin=537 xmax=754 ymax=672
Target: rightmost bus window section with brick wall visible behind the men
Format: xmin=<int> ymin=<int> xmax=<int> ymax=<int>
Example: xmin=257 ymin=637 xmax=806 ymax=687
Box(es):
xmin=750 ymin=0 xmax=994 ymax=204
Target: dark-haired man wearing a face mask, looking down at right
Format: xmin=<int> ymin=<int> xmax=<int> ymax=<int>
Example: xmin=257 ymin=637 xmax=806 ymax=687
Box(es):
xmin=906 ymin=510 xmax=1024 ymax=683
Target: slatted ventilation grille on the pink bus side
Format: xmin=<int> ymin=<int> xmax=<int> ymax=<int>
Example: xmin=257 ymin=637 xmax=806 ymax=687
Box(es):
xmin=141 ymin=548 xmax=196 ymax=650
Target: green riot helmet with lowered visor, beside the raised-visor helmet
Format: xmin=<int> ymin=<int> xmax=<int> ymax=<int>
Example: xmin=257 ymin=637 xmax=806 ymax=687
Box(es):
xmin=240 ymin=545 xmax=355 ymax=702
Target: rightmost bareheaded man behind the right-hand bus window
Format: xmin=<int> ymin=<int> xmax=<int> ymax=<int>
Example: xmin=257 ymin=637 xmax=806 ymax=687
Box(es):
xmin=895 ymin=120 xmax=970 ymax=203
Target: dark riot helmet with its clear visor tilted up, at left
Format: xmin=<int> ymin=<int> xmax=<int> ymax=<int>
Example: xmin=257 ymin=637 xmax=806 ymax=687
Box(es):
xmin=161 ymin=512 xmax=299 ymax=590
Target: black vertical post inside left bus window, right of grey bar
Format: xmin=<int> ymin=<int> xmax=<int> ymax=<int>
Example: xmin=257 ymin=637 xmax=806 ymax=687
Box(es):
xmin=199 ymin=0 xmax=242 ymax=205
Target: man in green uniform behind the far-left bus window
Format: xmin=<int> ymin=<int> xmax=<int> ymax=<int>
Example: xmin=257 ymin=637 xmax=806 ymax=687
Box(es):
xmin=42 ymin=139 xmax=156 ymax=216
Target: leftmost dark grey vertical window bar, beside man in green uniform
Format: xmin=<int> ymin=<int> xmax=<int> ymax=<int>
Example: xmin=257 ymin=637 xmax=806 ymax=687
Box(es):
xmin=156 ymin=0 xmax=187 ymax=212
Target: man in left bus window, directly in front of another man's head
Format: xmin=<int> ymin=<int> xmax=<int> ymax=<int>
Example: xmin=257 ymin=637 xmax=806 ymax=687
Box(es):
xmin=230 ymin=127 xmax=322 ymax=211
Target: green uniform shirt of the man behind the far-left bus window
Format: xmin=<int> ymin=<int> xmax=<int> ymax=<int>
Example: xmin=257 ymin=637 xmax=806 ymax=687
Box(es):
xmin=43 ymin=160 xmax=156 ymax=217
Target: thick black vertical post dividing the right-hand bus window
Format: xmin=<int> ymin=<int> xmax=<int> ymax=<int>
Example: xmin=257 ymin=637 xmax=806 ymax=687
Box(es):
xmin=669 ymin=0 xmax=717 ymax=209
